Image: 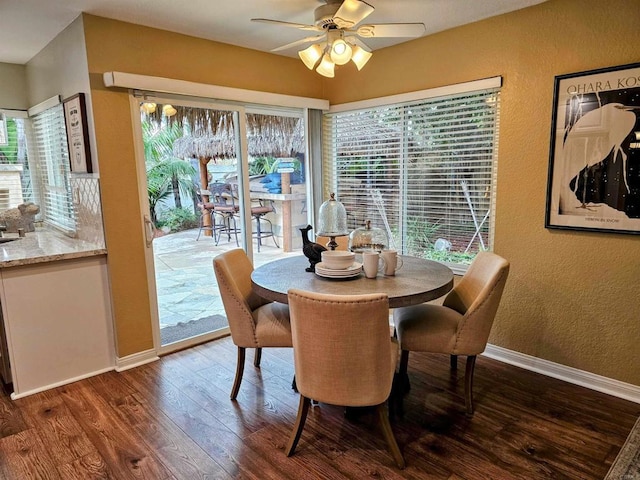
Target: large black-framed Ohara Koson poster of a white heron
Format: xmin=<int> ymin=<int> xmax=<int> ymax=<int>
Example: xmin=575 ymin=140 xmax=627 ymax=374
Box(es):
xmin=545 ymin=63 xmax=640 ymax=234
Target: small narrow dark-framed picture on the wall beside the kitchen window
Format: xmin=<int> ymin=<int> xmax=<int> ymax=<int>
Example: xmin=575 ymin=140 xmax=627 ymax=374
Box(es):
xmin=62 ymin=93 xmax=91 ymax=173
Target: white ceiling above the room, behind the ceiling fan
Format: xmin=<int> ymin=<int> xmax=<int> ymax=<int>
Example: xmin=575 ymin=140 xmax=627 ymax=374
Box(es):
xmin=0 ymin=0 xmax=546 ymax=65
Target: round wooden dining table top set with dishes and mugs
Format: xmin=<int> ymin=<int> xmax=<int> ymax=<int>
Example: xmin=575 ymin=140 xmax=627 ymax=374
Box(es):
xmin=251 ymin=255 xmax=453 ymax=308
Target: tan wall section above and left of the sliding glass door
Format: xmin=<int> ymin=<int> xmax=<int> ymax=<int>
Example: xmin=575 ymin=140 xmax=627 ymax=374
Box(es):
xmin=84 ymin=15 xmax=322 ymax=357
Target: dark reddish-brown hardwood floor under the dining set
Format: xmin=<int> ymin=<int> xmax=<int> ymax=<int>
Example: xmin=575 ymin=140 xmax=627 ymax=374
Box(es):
xmin=0 ymin=338 xmax=640 ymax=480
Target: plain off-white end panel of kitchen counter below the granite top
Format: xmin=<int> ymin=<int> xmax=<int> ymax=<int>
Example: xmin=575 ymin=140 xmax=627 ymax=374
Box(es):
xmin=0 ymin=255 xmax=115 ymax=398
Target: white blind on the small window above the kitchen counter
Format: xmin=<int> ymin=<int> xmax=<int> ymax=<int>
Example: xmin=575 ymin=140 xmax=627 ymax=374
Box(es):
xmin=30 ymin=103 xmax=76 ymax=233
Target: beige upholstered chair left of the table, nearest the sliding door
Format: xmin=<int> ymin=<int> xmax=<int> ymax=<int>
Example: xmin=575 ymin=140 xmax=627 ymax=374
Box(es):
xmin=213 ymin=248 xmax=292 ymax=400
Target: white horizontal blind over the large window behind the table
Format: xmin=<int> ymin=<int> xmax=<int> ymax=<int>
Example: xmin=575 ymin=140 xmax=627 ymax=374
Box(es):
xmin=323 ymin=88 xmax=499 ymax=271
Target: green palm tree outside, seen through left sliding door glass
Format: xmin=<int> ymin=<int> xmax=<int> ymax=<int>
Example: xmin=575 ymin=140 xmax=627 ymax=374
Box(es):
xmin=142 ymin=120 xmax=197 ymax=225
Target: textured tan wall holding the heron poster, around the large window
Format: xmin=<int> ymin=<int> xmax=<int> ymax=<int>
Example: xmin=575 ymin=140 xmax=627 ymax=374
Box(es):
xmin=326 ymin=0 xmax=640 ymax=385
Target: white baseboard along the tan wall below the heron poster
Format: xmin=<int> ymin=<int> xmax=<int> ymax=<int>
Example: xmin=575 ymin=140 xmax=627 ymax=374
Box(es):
xmin=483 ymin=345 xmax=640 ymax=403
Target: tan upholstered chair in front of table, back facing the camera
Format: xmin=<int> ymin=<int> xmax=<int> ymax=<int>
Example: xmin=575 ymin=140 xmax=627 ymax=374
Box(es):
xmin=286 ymin=289 xmax=405 ymax=468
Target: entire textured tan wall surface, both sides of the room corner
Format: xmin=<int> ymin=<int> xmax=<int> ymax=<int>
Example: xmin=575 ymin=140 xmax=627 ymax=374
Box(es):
xmin=85 ymin=0 xmax=640 ymax=385
